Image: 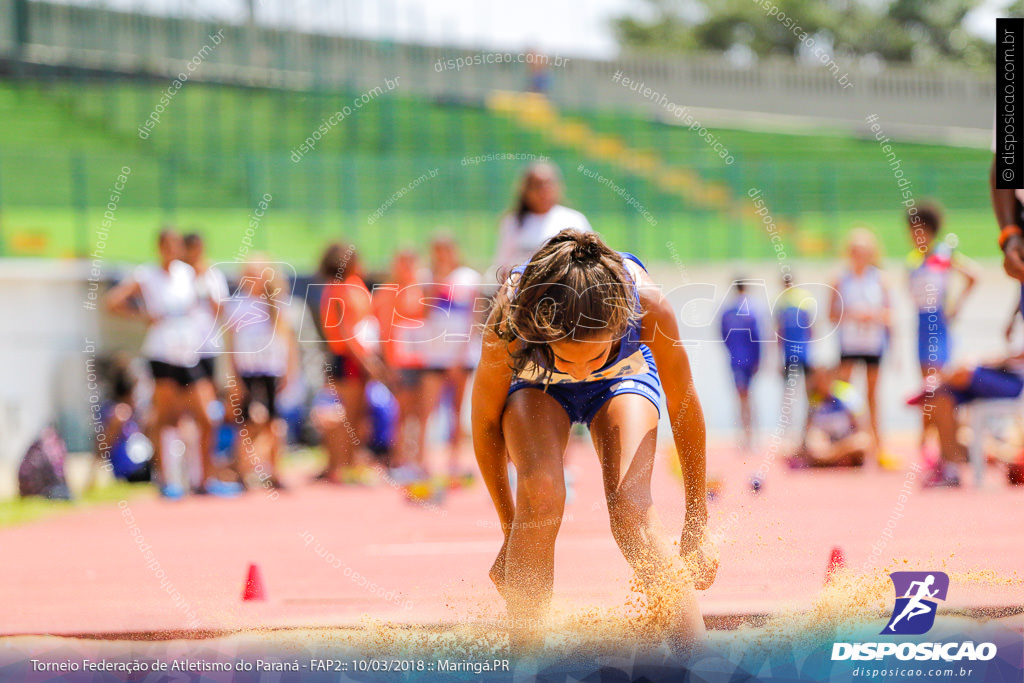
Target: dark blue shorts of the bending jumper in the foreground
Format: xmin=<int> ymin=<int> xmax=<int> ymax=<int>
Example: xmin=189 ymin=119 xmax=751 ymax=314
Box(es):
xmin=508 ymin=346 xmax=662 ymax=427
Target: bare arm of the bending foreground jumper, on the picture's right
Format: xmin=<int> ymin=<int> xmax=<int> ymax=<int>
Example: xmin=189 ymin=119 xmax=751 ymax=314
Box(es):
xmin=637 ymin=272 xmax=718 ymax=590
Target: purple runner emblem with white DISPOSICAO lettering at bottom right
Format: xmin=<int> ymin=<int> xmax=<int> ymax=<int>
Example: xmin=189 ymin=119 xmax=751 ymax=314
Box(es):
xmin=831 ymin=571 xmax=996 ymax=661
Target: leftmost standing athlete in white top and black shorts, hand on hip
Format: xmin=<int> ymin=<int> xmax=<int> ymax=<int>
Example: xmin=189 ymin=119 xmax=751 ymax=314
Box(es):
xmin=106 ymin=229 xmax=238 ymax=498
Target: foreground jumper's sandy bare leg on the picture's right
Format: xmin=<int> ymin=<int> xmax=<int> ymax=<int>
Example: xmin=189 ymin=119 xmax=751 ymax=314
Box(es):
xmin=591 ymin=393 xmax=705 ymax=647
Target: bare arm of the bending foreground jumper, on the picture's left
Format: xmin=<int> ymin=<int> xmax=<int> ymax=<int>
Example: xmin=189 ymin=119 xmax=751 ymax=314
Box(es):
xmin=471 ymin=293 xmax=515 ymax=539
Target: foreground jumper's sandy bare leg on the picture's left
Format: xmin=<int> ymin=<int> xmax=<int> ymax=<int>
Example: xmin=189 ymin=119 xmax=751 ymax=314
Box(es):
xmin=492 ymin=389 xmax=571 ymax=647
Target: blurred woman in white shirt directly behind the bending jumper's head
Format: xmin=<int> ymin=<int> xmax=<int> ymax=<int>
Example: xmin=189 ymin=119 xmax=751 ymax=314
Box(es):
xmin=495 ymin=162 xmax=593 ymax=271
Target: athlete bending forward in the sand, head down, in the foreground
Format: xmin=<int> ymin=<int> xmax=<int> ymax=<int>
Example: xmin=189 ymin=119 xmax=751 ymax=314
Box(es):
xmin=472 ymin=228 xmax=718 ymax=651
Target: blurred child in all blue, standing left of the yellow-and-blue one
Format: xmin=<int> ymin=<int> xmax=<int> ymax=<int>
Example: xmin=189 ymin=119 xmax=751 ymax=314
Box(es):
xmin=719 ymin=280 xmax=761 ymax=451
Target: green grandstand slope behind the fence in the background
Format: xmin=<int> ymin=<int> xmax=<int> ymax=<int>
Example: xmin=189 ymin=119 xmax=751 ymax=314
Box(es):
xmin=0 ymin=80 xmax=992 ymax=266
